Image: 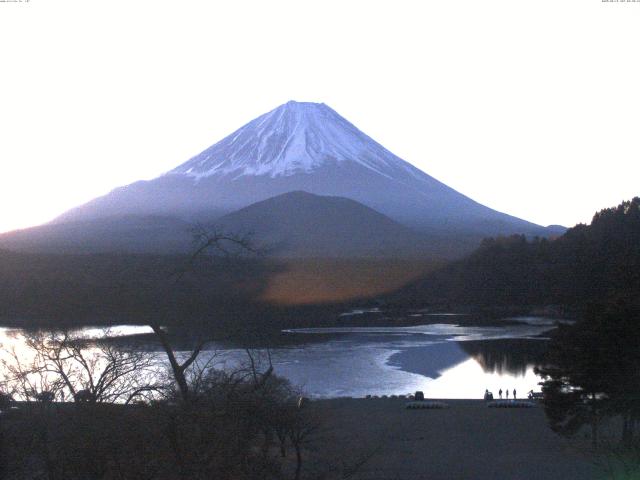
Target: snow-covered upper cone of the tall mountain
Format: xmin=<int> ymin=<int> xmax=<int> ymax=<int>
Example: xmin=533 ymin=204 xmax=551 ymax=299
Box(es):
xmin=168 ymin=101 xmax=415 ymax=179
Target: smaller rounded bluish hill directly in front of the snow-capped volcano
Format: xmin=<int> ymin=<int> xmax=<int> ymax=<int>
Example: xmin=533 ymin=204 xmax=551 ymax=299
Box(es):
xmin=216 ymin=191 xmax=434 ymax=257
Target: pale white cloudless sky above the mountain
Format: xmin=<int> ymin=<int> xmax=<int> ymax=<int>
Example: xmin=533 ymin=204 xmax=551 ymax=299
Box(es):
xmin=0 ymin=0 xmax=640 ymax=231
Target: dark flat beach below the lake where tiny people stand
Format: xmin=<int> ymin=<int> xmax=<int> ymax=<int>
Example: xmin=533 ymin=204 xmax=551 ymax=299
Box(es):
xmin=309 ymin=398 xmax=601 ymax=480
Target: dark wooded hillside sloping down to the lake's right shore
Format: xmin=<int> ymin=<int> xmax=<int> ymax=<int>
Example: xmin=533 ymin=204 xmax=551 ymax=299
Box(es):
xmin=393 ymin=197 xmax=640 ymax=308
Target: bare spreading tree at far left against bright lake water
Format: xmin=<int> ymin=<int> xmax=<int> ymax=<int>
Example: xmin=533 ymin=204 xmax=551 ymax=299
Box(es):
xmin=2 ymin=330 xmax=162 ymax=480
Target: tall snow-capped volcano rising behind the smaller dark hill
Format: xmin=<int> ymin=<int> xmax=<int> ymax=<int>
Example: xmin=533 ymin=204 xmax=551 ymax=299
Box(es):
xmin=0 ymin=101 xmax=558 ymax=254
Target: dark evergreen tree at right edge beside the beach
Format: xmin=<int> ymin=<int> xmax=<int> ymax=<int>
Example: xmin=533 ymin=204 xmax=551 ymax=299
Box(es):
xmin=537 ymin=301 xmax=640 ymax=445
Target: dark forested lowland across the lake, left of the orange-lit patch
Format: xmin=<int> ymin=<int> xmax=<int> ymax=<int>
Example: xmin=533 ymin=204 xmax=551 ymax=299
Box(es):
xmin=0 ymin=250 xmax=370 ymax=341
